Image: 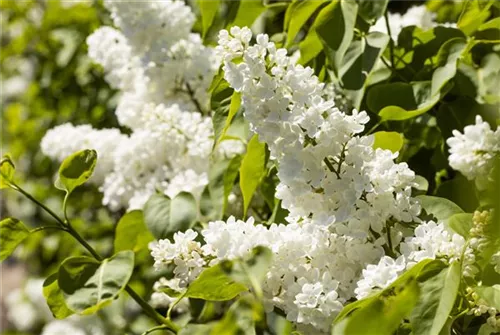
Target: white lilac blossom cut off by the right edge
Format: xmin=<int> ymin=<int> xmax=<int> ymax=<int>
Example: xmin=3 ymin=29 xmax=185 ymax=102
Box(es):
xmin=446 ymin=115 xmax=500 ymax=183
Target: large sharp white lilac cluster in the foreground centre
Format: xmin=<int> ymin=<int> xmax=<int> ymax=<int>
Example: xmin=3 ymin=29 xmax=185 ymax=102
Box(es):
xmin=150 ymin=27 xmax=472 ymax=333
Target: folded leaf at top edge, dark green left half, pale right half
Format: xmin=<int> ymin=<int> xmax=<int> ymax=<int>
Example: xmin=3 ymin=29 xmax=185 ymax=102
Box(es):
xmin=314 ymin=0 xmax=358 ymax=78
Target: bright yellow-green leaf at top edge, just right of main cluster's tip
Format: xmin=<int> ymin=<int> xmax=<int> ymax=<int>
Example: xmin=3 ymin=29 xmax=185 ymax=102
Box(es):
xmin=284 ymin=0 xmax=328 ymax=48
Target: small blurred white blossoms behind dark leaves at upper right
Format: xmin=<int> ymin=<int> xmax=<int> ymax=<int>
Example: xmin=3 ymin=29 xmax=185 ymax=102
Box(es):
xmin=370 ymin=5 xmax=456 ymax=41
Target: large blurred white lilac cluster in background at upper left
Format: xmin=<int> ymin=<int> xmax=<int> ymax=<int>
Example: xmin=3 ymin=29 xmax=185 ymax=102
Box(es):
xmin=42 ymin=0 xmax=243 ymax=210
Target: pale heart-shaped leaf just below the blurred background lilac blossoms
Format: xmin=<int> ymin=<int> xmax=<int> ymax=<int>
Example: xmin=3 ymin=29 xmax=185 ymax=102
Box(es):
xmin=144 ymin=192 xmax=198 ymax=239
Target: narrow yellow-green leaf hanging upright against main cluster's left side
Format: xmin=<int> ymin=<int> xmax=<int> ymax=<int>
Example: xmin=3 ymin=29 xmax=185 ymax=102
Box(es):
xmin=240 ymin=135 xmax=266 ymax=217
